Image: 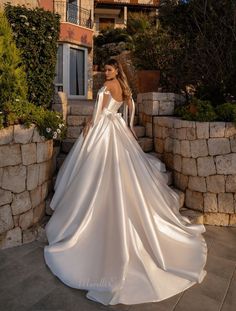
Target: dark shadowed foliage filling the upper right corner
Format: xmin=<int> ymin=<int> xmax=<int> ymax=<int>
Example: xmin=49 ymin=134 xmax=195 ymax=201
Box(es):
xmin=157 ymin=0 xmax=236 ymax=106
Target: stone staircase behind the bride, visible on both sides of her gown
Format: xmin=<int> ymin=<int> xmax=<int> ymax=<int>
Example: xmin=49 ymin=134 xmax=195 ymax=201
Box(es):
xmin=51 ymin=100 xmax=203 ymax=224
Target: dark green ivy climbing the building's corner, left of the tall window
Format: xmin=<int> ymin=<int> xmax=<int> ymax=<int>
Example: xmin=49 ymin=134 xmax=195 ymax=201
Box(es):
xmin=5 ymin=3 xmax=60 ymax=107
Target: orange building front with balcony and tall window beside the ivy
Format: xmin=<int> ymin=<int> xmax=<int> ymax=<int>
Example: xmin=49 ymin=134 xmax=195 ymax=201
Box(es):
xmin=0 ymin=0 xmax=94 ymax=100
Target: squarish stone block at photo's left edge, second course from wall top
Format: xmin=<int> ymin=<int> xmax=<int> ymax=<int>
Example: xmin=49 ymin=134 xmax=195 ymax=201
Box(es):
xmin=0 ymin=144 xmax=22 ymax=167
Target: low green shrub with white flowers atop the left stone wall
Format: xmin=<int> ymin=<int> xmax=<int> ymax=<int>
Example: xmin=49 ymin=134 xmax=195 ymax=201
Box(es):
xmin=0 ymin=98 xmax=66 ymax=139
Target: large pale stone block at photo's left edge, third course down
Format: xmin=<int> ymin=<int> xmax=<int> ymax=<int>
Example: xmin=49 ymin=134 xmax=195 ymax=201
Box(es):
xmin=2 ymin=165 xmax=26 ymax=193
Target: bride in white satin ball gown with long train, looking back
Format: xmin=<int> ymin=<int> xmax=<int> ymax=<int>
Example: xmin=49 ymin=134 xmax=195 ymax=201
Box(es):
xmin=44 ymin=59 xmax=207 ymax=305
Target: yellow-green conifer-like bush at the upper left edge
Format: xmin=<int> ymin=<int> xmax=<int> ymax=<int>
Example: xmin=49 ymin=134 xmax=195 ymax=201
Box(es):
xmin=0 ymin=12 xmax=27 ymax=107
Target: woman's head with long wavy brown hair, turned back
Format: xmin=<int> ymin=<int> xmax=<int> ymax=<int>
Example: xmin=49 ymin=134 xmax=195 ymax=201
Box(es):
xmin=104 ymin=58 xmax=132 ymax=98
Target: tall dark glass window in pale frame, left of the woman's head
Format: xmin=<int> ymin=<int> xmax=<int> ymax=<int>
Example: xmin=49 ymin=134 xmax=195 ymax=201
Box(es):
xmin=69 ymin=48 xmax=85 ymax=95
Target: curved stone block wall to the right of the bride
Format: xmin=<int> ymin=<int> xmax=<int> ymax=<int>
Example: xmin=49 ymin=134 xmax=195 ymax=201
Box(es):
xmin=138 ymin=93 xmax=236 ymax=226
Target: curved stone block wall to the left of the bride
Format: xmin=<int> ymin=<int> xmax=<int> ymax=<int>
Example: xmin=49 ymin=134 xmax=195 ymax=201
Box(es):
xmin=0 ymin=125 xmax=53 ymax=248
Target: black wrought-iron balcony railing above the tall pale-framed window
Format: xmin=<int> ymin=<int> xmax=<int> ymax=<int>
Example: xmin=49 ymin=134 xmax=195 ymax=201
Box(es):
xmin=54 ymin=1 xmax=93 ymax=28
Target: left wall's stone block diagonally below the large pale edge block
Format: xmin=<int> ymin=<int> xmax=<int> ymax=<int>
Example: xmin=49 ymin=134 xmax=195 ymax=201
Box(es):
xmin=11 ymin=191 xmax=31 ymax=215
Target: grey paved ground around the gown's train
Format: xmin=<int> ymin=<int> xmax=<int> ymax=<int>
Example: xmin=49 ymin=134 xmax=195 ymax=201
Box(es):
xmin=0 ymin=225 xmax=236 ymax=311
